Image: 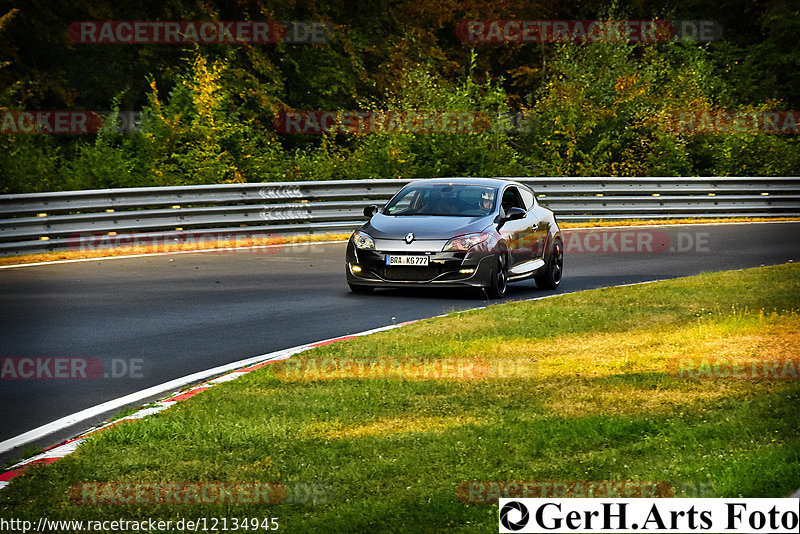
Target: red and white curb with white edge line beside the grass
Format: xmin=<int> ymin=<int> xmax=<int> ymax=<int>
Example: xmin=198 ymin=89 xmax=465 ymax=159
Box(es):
xmin=0 ymin=320 xmax=417 ymax=490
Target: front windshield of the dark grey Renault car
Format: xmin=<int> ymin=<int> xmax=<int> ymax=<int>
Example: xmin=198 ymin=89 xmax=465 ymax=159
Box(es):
xmin=383 ymin=184 xmax=497 ymax=217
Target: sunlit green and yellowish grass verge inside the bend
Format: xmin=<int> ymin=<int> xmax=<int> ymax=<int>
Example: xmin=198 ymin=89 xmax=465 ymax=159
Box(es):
xmin=0 ymin=265 xmax=800 ymax=532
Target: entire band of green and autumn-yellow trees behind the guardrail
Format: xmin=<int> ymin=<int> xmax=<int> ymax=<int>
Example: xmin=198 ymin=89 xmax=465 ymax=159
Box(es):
xmin=0 ymin=0 xmax=800 ymax=193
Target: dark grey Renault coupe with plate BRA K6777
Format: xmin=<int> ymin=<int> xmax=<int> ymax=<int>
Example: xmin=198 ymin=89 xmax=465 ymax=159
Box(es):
xmin=345 ymin=178 xmax=564 ymax=298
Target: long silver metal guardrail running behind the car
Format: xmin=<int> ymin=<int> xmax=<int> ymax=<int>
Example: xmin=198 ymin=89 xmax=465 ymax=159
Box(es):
xmin=0 ymin=177 xmax=800 ymax=255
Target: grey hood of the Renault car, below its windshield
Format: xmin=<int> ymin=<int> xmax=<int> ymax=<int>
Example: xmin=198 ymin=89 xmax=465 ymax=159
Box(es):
xmin=363 ymin=213 xmax=494 ymax=239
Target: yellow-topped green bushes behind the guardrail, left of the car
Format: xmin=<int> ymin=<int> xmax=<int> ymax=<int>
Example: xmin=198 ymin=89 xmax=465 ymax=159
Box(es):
xmin=54 ymin=54 xmax=290 ymax=187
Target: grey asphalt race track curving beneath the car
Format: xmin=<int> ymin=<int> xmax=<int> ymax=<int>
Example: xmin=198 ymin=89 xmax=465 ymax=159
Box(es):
xmin=0 ymin=222 xmax=800 ymax=460
